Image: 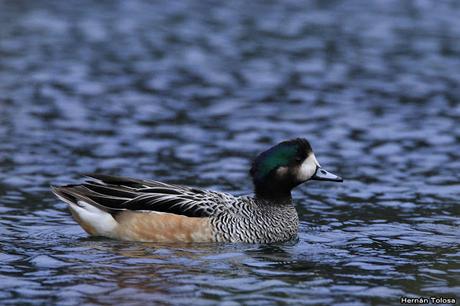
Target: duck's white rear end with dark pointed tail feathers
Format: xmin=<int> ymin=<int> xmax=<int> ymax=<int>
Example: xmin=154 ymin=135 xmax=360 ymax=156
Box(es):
xmin=51 ymin=185 xmax=118 ymax=238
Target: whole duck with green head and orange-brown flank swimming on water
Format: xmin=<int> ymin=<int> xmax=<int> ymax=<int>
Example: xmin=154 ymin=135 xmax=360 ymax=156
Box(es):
xmin=51 ymin=138 xmax=343 ymax=244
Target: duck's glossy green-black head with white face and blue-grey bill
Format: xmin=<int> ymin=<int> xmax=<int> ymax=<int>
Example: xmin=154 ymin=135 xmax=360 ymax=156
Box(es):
xmin=250 ymin=138 xmax=343 ymax=199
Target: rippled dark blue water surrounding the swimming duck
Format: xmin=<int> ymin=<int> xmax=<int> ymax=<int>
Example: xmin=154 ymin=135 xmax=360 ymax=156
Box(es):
xmin=0 ymin=1 xmax=460 ymax=305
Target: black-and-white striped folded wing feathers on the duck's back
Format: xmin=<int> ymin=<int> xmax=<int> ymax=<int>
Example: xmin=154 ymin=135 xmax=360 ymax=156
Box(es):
xmin=54 ymin=174 xmax=236 ymax=217
